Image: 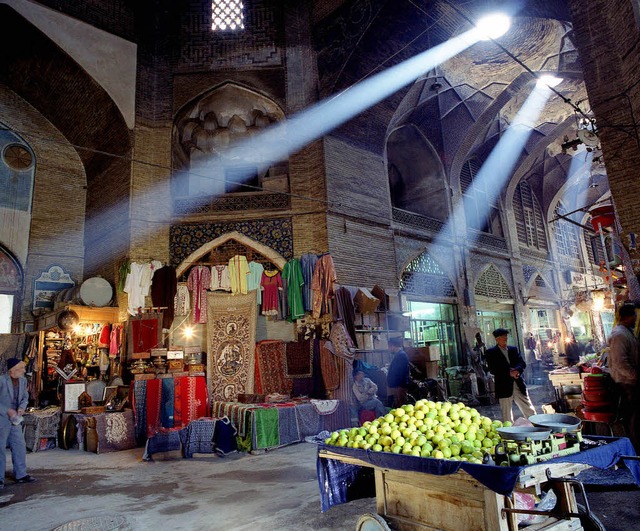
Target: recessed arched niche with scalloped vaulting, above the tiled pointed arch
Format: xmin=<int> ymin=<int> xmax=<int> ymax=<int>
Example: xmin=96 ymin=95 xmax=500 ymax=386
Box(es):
xmin=172 ymin=82 xmax=289 ymax=198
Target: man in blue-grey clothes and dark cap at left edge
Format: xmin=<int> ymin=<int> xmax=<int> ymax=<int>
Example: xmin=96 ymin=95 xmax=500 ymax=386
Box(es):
xmin=0 ymin=358 xmax=35 ymax=489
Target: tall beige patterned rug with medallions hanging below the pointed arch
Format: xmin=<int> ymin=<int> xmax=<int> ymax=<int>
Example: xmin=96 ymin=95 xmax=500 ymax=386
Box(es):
xmin=207 ymin=291 xmax=257 ymax=401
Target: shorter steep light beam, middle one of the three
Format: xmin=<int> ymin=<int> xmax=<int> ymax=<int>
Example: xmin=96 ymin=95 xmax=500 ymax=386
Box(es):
xmin=433 ymin=79 xmax=553 ymax=270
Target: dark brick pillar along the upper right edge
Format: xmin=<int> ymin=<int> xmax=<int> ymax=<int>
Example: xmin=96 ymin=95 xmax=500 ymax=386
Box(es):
xmin=568 ymin=0 xmax=640 ymax=300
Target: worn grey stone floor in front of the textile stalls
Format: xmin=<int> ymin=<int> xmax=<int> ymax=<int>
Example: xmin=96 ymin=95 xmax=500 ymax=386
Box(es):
xmin=0 ymin=380 xmax=640 ymax=531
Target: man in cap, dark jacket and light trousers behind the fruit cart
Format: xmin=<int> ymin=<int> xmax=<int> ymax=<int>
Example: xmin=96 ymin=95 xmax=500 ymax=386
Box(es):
xmin=485 ymin=328 xmax=536 ymax=422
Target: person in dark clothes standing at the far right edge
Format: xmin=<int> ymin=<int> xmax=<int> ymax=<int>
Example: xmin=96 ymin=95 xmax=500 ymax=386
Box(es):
xmin=607 ymin=303 xmax=640 ymax=453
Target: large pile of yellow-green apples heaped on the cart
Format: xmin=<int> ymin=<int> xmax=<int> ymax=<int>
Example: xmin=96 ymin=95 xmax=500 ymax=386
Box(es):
xmin=325 ymin=400 xmax=511 ymax=463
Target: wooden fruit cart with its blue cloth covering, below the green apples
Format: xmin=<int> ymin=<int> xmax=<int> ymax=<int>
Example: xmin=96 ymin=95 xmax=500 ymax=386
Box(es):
xmin=317 ymin=437 xmax=640 ymax=531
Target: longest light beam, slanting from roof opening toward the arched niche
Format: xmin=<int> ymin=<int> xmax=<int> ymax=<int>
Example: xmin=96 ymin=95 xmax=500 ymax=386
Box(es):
xmin=192 ymin=28 xmax=500 ymax=187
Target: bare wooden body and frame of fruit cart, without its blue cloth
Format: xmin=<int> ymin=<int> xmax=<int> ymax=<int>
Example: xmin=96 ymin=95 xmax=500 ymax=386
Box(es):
xmin=318 ymin=449 xmax=598 ymax=531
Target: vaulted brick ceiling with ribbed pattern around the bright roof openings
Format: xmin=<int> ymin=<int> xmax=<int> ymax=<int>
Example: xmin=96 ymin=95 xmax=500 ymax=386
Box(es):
xmin=315 ymin=0 xmax=607 ymax=218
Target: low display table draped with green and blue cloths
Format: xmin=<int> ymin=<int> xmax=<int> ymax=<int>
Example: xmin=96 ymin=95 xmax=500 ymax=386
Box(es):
xmin=211 ymin=400 xmax=348 ymax=452
